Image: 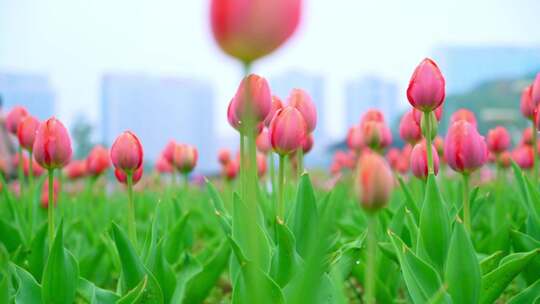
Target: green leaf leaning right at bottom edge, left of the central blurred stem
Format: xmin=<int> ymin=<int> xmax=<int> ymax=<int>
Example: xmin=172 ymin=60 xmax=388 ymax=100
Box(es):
xmin=183 ymin=242 xmax=231 ymax=303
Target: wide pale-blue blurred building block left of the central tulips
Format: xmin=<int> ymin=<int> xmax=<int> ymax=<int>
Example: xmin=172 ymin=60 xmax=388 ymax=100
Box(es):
xmin=101 ymin=74 xmax=217 ymax=173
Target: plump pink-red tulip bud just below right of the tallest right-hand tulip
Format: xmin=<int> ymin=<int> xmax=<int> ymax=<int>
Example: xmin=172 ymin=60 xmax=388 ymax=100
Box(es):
xmin=444 ymin=120 xmax=488 ymax=173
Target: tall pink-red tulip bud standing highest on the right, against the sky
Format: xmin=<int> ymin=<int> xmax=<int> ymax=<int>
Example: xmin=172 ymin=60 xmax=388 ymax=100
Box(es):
xmin=407 ymin=58 xmax=445 ymax=112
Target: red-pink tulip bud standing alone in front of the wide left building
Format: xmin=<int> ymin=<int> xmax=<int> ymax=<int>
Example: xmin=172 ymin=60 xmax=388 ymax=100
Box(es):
xmin=111 ymin=131 xmax=143 ymax=173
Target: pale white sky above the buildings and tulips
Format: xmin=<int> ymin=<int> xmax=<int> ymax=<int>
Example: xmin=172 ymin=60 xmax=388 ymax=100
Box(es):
xmin=0 ymin=0 xmax=540 ymax=138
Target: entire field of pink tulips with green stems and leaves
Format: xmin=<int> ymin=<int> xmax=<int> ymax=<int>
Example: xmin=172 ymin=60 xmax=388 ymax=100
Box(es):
xmin=0 ymin=0 xmax=540 ymax=304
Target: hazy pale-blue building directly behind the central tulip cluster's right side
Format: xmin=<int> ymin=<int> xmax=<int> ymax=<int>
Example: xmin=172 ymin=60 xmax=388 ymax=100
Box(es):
xmin=269 ymin=71 xmax=331 ymax=166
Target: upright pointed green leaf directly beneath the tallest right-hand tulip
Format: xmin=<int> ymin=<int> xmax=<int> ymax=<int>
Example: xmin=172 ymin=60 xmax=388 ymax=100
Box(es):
xmin=420 ymin=174 xmax=450 ymax=273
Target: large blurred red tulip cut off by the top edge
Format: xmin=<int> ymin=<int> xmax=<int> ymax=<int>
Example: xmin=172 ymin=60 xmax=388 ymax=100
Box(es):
xmin=210 ymin=0 xmax=302 ymax=63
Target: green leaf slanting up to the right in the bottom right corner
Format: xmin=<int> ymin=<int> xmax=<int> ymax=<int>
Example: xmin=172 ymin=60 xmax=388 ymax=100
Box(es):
xmin=480 ymin=249 xmax=540 ymax=304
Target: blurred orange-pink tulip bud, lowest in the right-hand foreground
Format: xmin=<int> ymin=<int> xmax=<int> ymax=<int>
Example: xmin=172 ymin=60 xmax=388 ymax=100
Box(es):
xmin=357 ymin=153 xmax=394 ymax=212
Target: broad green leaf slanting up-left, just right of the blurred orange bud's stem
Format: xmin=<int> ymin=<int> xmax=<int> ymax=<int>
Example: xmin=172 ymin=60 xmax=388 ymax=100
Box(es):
xmin=389 ymin=231 xmax=448 ymax=304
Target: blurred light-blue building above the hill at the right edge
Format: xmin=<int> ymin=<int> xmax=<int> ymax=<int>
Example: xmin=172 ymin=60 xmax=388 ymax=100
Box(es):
xmin=433 ymin=46 xmax=540 ymax=95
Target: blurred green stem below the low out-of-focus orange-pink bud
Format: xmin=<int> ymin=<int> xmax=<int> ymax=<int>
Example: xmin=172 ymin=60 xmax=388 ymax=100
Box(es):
xmin=364 ymin=213 xmax=377 ymax=304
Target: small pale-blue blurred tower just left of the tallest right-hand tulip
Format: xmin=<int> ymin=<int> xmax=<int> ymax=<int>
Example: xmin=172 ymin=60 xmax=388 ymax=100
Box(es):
xmin=345 ymin=76 xmax=403 ymax=128
